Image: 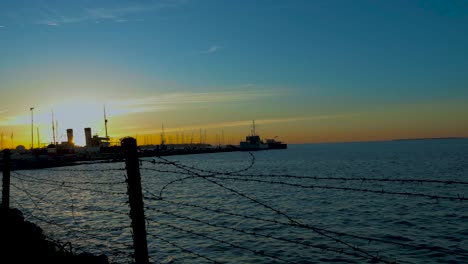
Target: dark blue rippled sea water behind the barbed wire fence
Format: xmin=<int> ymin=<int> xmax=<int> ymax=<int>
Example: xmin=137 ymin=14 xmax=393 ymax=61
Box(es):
xmin=7 ymin=140 xmax=468 ymax=263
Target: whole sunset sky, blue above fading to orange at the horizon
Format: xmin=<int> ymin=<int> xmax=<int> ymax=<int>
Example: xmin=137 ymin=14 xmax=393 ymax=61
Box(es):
xmin=0 ymin=0 xmax=468 ymax=147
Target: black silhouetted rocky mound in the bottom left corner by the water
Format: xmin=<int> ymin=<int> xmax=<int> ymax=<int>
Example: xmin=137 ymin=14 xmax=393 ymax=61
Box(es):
xmin=0 ymin=209 xmax=109 ymax=264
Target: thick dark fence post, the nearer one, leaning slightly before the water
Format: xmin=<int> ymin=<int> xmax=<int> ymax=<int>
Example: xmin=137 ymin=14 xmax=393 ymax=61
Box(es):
xmin=121 ymin=137 xmax=149 ymax=264
